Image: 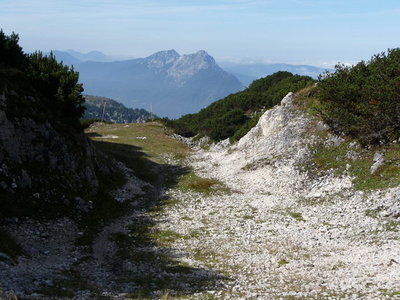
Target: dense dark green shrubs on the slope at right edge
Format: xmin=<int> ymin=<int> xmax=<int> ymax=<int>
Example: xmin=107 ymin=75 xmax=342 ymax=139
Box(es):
xmin=317 ymin=48 xmax=400 ymax=145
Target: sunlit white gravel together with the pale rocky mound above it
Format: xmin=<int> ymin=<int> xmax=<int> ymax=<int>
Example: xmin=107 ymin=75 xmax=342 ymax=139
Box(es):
xmin=155 ymin=94 xmax=400 ymax=299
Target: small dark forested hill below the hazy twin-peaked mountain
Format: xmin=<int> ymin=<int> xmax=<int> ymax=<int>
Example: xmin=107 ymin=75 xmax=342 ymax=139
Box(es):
xmin=83 ymin=96 xmax=155 ymax=123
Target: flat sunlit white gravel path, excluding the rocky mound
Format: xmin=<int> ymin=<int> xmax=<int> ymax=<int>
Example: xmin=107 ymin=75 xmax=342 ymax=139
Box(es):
xmin=153 ymin=147 xmax=400 ymax=299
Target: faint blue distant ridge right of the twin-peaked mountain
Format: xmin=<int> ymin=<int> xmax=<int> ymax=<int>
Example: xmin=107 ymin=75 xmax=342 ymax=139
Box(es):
xmin=220 ymin=62 xmax=332 ymax=86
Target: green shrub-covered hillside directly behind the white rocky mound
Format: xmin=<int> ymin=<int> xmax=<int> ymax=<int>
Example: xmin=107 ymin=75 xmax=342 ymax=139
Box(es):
xmin=165 ymin=72 xmax=314 ymax=141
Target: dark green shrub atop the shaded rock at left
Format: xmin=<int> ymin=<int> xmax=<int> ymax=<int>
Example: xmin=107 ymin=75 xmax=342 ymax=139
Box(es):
xmin=0 ymin=30 xmax=85 ymax=130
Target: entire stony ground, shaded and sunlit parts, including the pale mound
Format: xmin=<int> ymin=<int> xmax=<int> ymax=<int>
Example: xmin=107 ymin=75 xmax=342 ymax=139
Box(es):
xmin=0 ymin=95 xmax=400 ymax=299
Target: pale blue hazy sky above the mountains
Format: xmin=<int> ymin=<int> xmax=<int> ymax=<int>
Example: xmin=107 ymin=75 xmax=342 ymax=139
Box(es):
xmin=0 ymin=0 xmax=400 ymax=66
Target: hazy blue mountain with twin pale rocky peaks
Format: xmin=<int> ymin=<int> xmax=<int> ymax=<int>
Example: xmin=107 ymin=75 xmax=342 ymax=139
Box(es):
xmin=53 ymin=50 xmax=243 ymax=118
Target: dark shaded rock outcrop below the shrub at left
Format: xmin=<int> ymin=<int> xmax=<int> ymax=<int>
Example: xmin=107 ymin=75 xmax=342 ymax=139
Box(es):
xmin=0 ymin=88 xmax=107 ymax=215
